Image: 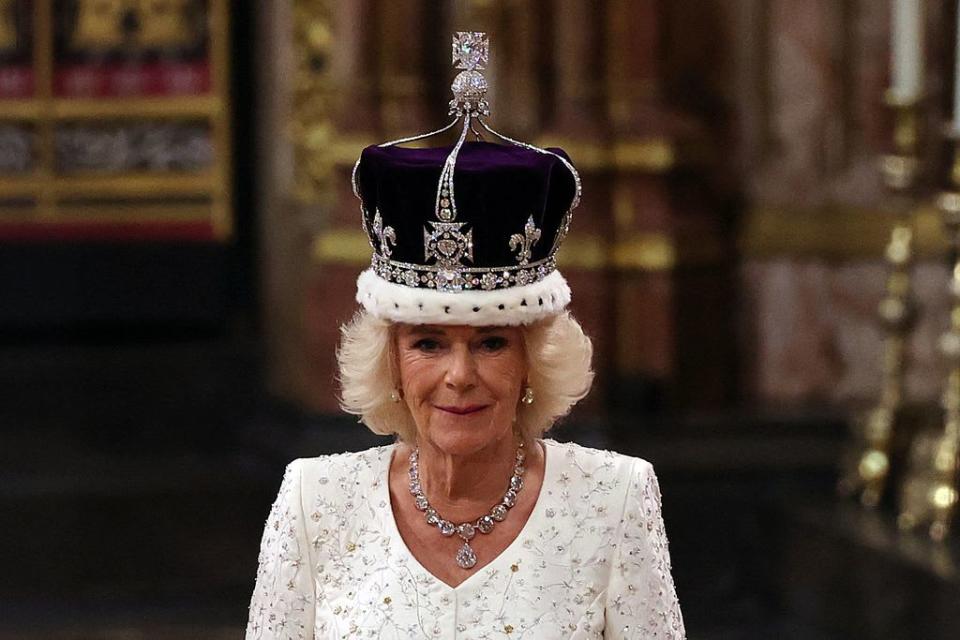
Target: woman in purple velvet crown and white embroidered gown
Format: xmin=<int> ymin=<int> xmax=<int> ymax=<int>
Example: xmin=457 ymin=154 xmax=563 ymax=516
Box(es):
xmin=247 ymin=34 xmax=684 ymax=640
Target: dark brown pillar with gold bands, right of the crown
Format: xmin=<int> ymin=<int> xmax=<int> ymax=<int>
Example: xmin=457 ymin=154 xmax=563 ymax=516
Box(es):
xmin=606 ymin=0 xmax=733 ymax=411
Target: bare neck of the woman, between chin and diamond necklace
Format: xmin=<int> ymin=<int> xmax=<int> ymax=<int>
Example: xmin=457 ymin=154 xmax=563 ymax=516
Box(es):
xmin=410 ymin=435 xmax=516 ymax=520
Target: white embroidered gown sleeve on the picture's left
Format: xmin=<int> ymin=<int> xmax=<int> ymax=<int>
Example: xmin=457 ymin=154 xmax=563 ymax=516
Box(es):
xmin=246 ymin=460 xmax=314 ymax=640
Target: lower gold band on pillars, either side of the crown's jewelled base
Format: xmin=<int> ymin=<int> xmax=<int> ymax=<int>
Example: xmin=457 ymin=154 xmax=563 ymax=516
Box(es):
xmin=312 ymin=229 xmax=723 ymax=272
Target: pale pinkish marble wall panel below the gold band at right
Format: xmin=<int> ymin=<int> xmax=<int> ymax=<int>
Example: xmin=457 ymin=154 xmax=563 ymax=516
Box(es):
xmin=740 ymin=258 xmax=949 ymax=405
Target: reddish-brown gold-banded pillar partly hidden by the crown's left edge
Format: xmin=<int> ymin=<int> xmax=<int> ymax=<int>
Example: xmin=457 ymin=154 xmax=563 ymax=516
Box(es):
xmin=303 ymin=0 xmax=390 ymax=413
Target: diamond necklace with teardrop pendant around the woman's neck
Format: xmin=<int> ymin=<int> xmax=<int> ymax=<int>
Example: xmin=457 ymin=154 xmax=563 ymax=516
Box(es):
xmin=409 ymin=442 xmax=526 ymax=569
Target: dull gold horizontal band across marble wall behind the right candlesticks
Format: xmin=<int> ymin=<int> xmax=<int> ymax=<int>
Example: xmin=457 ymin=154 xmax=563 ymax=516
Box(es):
xmin=738 ymin=203 xmax=948 ymax=260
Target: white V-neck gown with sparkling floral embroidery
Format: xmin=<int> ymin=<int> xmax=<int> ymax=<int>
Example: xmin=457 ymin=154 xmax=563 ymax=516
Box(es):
xmin=247 ymin=440 xmax=685 ymax=640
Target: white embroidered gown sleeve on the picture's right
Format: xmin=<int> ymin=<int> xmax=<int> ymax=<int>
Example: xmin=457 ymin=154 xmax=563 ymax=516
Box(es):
xmin=603 ymin=460 xmax=686 ymax=640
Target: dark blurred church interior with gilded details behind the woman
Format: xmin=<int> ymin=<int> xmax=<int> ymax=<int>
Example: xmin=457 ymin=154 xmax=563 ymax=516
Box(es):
xmin=0 ymin=0 xmax=960 ymax=640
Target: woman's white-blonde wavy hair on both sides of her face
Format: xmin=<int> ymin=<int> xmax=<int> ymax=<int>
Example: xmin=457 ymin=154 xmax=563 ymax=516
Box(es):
xmin=337 ymin=310 xmax=593 ymax=442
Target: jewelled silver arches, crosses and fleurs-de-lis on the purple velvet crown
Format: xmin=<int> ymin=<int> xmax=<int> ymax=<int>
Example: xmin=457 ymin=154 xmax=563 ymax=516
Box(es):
xmin=352 ymin=31 xmax=582 ymax=291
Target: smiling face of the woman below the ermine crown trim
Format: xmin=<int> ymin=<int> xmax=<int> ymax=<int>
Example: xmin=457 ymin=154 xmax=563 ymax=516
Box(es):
xmin=396 ymin=324 xmax=527 ymax=456
